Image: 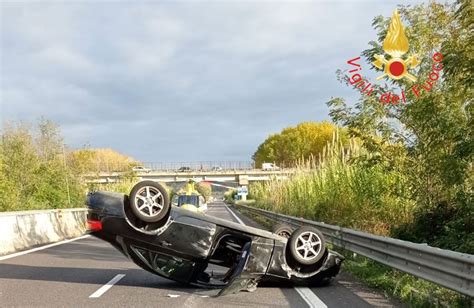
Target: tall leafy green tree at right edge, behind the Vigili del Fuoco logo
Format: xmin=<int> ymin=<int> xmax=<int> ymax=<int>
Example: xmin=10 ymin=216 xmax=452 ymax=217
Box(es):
xmin=328 ymin=1 xmax=474 ymax=250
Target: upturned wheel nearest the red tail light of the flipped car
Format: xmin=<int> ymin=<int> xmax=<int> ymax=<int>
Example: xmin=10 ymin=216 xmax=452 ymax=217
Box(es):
xmin=129 ymin=181 xmax=170 ymax=222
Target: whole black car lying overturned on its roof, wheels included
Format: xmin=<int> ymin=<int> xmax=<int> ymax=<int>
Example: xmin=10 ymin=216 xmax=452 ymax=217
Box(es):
xmin=87 ymin=181 xmax=343 ymax=295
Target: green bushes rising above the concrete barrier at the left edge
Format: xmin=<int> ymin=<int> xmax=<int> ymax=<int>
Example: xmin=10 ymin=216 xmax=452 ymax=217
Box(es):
xmin=0 ymin=120 xmax=85 ymax=211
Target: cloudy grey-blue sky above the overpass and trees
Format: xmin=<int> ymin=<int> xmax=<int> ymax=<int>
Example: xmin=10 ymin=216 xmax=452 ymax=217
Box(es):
xmin=0 ymin=0 xmax=419 ymax=161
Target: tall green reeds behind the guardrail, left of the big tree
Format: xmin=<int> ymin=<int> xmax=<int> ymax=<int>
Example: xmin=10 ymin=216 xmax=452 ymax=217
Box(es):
xmin=250 ymin=139 xmax=414 ymax=235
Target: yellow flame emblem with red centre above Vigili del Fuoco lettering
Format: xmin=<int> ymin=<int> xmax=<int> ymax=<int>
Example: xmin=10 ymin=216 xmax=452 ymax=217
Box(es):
xmin=373 ymin=10 xmax=420 ymax=82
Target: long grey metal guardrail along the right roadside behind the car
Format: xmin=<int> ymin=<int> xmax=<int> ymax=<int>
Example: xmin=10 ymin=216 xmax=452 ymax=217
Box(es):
xmin=237 ymin=205 xmax=474 ymax=297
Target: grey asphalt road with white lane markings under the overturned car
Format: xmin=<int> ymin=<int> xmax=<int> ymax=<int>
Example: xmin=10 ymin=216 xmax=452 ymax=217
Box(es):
xmin=0 ymin=202 xmax=397 ymax=308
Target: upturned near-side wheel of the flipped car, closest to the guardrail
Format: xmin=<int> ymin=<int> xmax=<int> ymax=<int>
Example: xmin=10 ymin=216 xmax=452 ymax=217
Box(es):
xmin=288 ymin=226 xmax=326 ymax=265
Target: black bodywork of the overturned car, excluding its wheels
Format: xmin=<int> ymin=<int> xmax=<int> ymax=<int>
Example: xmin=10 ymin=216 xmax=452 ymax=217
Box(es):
xmin=87 ymin=192 xmax=343 ymax=295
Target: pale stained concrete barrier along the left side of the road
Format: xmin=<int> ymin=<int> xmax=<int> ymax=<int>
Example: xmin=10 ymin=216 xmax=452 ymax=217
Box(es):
xmin=0 ymin=208 xmax=86 ymax=255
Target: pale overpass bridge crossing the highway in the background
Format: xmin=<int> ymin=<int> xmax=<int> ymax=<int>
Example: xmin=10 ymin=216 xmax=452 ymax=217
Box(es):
xmin=83 ymin=169 xmax=294 ymax=186
